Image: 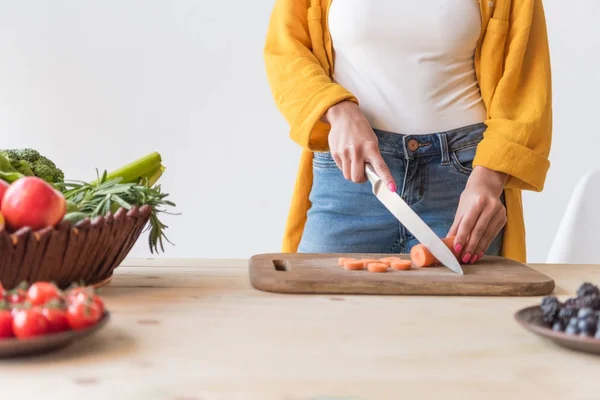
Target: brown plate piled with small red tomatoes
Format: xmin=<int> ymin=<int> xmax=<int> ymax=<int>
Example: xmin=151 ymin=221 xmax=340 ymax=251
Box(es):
xmin=0 ymin=282 xmax=110 ymax=357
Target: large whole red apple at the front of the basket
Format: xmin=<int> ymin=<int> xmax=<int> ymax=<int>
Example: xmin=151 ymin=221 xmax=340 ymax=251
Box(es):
xmin=0 ymin=176 xmax=67 ymax=231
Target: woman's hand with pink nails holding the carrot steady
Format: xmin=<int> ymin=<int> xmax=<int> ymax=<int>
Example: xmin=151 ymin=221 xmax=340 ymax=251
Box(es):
xmin=448 ymin=166 xmax=507 ymax=264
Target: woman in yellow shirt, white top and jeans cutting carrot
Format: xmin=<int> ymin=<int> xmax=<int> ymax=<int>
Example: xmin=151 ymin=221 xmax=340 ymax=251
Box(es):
xmin=264 ymin=0 xmax=552 ymax=263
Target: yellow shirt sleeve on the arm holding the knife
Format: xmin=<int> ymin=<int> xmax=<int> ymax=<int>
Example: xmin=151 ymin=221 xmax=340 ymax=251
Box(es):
xmin=264 ymin=0 xmax=358 ymax=151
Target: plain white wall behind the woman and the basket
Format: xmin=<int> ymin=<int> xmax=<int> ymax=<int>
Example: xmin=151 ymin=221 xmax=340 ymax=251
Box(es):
xmin=0 ymin=0 xmax=600 ymax=261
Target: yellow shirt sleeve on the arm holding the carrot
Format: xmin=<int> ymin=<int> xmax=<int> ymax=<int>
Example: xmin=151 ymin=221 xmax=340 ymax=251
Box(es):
xmin=473 ymin=0 xmax=552 ymax=191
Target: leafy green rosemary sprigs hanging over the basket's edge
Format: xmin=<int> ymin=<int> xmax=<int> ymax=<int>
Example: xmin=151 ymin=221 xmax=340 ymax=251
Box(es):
xmin=61 ymin=171 xmax=176 ymax=253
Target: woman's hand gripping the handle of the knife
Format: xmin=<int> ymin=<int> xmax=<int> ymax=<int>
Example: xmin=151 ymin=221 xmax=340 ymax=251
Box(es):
xmin=323 ymin=101 xmax=396 ymax=192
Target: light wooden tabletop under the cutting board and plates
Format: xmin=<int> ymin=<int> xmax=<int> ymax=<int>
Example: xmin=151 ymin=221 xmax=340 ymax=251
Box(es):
xmin=0 ymin=260 xmax=600 ymax=400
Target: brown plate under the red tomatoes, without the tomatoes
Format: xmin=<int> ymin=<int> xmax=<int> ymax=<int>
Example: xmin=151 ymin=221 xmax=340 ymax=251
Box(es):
xmin=0 ymin=311 xmax=110 ymax=358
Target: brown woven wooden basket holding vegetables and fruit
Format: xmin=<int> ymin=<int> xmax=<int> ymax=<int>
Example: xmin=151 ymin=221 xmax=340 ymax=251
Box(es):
xmin=0 ymin=206 xmax=151 ymax=289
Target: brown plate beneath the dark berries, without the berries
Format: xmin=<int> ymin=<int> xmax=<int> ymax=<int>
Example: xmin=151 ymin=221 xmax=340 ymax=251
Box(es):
xmin=515 ymin=306 xmax=600 ymax=354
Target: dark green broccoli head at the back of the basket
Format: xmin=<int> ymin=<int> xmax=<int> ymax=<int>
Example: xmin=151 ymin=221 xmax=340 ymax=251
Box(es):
xmin=0 ymin=149 xmax=65 ymax=183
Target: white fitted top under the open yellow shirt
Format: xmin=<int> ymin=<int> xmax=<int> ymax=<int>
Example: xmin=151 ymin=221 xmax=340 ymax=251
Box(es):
xmin=328 ymin=0 xmax=486 ymax=134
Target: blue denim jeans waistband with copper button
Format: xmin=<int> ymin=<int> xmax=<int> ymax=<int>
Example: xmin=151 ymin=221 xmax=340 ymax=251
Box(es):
xmin=374 ymin=123 xmax=486 ymax=160
